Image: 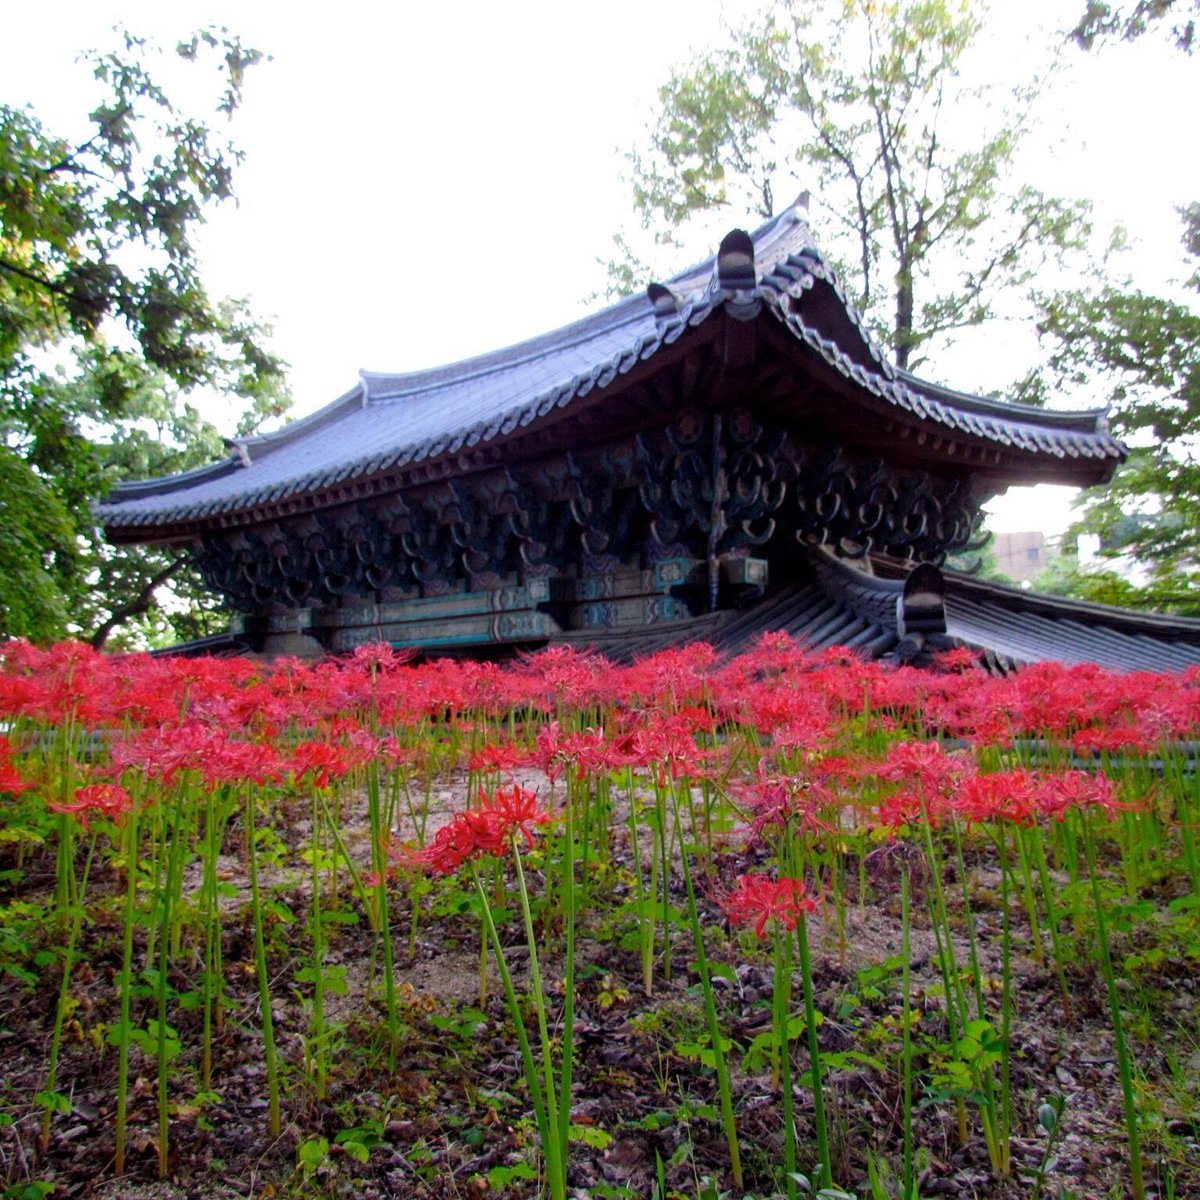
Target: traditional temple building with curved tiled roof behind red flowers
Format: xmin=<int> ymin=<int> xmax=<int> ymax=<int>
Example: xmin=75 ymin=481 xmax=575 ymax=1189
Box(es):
xmin=96 ymin=209 xmax=1200 ymax=670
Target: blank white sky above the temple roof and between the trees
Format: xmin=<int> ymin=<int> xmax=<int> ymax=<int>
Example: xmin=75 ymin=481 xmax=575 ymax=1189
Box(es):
xmin=0 ymin=0 xmax=1200 ymax=532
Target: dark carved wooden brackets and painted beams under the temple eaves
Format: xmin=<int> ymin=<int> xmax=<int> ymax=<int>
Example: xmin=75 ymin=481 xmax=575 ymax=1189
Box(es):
xmin=196 ymin=408 xmax=982 ymax=644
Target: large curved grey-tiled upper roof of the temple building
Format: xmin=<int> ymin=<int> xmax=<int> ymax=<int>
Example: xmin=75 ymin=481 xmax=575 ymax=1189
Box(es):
xmin=96 ymin=210 xmax=1123 ymax=538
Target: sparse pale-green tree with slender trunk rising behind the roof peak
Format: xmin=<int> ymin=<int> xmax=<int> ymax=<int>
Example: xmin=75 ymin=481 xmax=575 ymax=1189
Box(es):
xmin=632 ymin=0 xmax=1087 ymax=367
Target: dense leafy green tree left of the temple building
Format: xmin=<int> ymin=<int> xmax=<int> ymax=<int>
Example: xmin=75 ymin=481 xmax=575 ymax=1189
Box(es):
xmin=0 ymin=30 xmax=286 ymax=643
